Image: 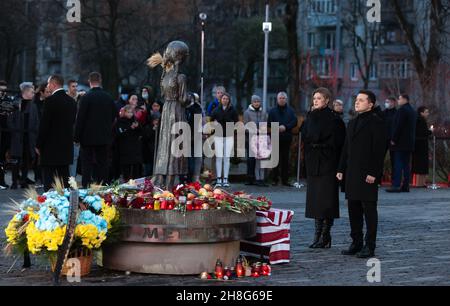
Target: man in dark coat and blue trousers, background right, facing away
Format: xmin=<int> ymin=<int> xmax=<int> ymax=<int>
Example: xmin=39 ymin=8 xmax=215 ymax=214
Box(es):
xmin=386 ymin=94 xmax=417 ymax=192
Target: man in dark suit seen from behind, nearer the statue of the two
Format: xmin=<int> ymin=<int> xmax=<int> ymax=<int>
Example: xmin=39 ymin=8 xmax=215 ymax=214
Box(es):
xmin=75 ymin=72 xmax=117 ymax=188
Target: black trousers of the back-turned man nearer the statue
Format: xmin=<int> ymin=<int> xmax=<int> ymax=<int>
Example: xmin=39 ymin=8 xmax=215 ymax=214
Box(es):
xmin=81 ymin=145 xmax=108 ymax=188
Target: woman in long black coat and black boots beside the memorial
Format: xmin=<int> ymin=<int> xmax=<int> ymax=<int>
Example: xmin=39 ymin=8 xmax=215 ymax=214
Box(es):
xmin=302 ymin=88 xmax=345 ymax=248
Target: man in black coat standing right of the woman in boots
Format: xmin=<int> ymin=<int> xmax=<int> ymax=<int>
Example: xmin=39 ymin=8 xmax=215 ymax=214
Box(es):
xmin=336 ymin=90 xmax=386 ymax=258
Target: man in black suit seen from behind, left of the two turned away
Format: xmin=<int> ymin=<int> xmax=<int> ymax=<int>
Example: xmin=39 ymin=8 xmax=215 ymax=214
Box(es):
xmin=36 ymin=75 xmax=77 ymax=191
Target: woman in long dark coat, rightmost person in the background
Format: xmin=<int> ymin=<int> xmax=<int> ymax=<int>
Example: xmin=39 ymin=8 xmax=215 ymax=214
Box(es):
xmin=412 ymin=106 xmax=432 ymax=187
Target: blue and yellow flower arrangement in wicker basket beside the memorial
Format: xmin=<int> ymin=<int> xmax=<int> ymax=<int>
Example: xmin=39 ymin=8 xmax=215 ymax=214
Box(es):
xmin=5 ymin=182 xmax=119 ymax=274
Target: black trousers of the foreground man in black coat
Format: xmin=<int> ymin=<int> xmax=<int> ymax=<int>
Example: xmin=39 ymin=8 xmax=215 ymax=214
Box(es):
xmin=348 ymin=200 xmax=378 ymax=250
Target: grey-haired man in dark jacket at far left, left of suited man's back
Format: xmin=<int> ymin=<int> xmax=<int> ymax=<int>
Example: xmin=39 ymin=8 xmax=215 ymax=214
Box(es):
xmin=7 ymin=82 xmax=39 ymax=189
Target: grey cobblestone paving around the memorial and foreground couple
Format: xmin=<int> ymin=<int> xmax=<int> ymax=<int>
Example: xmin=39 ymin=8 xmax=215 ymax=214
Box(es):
xmin=0 ymin=180 xmax=450 ymax=286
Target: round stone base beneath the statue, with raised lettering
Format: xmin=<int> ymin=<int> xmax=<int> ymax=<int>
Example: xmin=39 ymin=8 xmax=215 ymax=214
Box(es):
xmin=103 ymin=209 xmax=256 ymax=275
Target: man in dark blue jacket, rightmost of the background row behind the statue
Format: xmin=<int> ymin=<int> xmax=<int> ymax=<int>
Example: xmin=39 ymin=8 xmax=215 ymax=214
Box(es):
xmin=267 ymin=92 xmax=298 ymax=186
